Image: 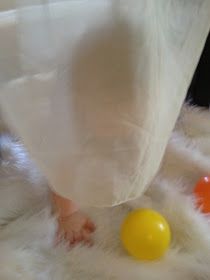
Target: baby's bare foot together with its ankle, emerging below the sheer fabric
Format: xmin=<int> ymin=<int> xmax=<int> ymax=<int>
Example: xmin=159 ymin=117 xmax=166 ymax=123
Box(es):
xmin=52 ymin=193 xmax=95 ymax=245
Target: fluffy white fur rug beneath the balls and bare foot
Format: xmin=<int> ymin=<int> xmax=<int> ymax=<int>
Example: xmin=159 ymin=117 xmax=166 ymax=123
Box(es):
xmin=0 ymin=108 xmax=210 ymax=280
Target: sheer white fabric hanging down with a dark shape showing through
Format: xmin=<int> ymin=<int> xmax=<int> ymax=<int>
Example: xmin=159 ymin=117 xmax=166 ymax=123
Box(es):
xmin=0 ymin=0 xmax=210 ymax=206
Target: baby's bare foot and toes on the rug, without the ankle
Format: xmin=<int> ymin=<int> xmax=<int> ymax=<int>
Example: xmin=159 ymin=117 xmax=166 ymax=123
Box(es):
xmin=57 ymin=211 xmax=95 ymax=245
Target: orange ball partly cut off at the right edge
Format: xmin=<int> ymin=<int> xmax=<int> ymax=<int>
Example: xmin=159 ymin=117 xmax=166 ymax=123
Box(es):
xmin=194 ymin=176 xmax=210 ymax=213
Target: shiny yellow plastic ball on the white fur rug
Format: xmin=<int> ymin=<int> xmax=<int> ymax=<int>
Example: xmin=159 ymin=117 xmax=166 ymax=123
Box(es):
xmin=121 ymin=209 xmax=171 ymax=261
